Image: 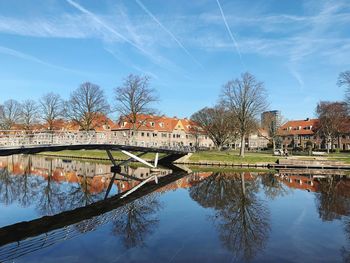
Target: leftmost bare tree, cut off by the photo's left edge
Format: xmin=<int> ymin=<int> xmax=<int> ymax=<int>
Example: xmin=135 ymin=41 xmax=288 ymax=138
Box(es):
xmin=0 ymin=100 xmax=21 ymax=130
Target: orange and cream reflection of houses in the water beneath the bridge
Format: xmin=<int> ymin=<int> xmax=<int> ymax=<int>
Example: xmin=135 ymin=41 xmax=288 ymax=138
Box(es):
xmin=0 ymin=155 xmax=211 ymax=194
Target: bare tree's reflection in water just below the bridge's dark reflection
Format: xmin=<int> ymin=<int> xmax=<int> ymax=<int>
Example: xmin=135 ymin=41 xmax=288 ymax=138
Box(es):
xmin=113 ymin=194 xmax=161 ymax=248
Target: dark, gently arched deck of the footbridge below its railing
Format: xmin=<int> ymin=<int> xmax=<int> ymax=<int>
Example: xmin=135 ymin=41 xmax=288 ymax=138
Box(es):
xmin=0 ymin=144 xmax=188 ymax=156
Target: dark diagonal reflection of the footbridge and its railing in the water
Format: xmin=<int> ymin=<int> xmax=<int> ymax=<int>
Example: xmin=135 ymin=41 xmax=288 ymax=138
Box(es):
xmin=0 ymin=167 xmax=187 ymax=262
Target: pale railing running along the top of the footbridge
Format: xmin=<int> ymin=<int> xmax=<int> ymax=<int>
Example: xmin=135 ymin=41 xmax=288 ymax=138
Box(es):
xmin=0 ymin=130 xmax=194 ymax=152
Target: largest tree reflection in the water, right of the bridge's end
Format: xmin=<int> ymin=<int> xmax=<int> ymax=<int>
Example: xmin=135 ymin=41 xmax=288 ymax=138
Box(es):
xmin=190 ymin=173 xmax=270 ymax=260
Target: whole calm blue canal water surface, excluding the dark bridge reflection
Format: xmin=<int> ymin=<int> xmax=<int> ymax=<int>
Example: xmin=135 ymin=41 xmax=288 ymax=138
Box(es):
xmin=0 ymin=156 xmax=350 ymax=262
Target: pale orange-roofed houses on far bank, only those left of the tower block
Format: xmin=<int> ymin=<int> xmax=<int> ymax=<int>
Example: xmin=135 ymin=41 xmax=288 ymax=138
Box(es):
xmin=4 ymin=114 xmax=269 ymax=149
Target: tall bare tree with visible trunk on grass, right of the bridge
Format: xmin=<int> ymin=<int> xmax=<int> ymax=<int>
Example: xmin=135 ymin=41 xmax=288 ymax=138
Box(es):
xmin=221 ymin=72 xmax=267 ymax=157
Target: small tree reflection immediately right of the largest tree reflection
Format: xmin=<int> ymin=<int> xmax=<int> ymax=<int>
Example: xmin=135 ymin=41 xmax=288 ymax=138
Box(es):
xmin=261 ymin=173 xmax=289 ymax=200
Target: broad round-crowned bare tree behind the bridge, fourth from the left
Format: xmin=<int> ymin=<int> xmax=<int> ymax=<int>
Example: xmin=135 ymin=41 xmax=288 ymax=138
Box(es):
xmin=68 ymin=82 xmax=109 ymax=131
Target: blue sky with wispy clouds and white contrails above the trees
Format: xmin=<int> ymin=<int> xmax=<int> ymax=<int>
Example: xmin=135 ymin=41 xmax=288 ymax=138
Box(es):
xmin=0 ymin=0 xmax=350 ymax=119
